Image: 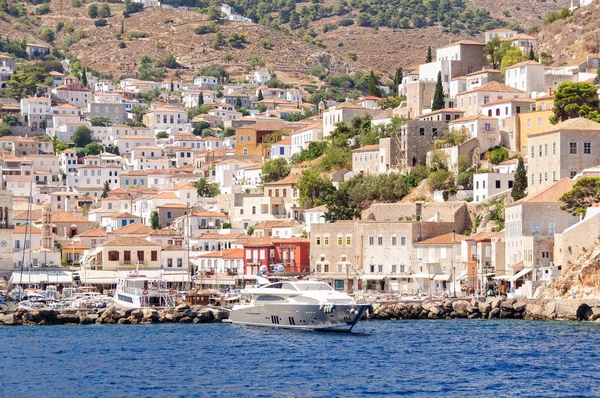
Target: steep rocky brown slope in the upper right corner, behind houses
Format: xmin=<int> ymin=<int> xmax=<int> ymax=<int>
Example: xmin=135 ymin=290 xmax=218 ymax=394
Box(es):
xmin=538 ymin=2 xmax=600 ymax=66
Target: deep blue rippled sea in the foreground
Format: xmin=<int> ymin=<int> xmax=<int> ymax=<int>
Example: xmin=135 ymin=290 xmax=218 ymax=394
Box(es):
xmin=0 ymin=320 xmax=600 ymax=397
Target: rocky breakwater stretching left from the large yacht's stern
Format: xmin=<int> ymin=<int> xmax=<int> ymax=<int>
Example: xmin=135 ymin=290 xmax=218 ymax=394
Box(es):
xmin=0 ymin=304 xmax=229 ymax=325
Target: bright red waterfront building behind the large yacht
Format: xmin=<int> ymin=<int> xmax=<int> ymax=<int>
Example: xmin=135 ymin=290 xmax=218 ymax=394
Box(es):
xmin=244 ymin=238 xmax=310 ymax=275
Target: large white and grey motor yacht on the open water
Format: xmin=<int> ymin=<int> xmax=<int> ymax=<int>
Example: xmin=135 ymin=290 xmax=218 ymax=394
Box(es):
xmin=229 ymin=280 xmax=370 ymax=332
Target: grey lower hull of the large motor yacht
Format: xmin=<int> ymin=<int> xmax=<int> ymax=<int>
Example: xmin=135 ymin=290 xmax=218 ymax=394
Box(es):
xmin=229 ymin=303 xmax=370 ymax=332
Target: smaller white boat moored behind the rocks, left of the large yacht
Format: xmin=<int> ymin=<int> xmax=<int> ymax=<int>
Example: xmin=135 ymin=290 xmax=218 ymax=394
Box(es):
xmin=113 ymin=274 xmax=178 ymax=309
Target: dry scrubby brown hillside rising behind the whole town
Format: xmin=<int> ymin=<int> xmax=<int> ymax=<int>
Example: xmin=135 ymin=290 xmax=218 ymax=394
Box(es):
xmin=0 ymin=0 xmax=580 ymax=79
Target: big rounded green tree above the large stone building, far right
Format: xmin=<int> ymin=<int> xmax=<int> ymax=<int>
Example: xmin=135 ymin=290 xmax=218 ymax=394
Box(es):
xmin=550 ymin=82 xmax=600 ymax=124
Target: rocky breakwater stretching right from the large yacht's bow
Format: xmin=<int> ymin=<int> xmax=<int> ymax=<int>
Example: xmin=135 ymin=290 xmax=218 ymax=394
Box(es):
xmin=368 ymin=297 xmax=600 ymax=322
